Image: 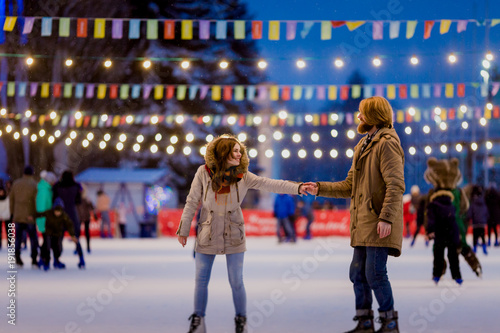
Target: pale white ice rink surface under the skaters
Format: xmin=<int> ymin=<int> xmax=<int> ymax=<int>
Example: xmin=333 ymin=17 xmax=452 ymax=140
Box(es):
xmin=0 ymin=237 xmax=500 ymax=333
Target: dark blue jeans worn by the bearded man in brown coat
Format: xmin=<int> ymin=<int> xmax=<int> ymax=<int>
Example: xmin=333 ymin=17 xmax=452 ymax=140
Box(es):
xmin=349 ymin=246 xmax=394 ymax=312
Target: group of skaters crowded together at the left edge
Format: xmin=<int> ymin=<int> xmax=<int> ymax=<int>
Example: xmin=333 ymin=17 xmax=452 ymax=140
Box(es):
xmin=0 ymin=166 xmax=126 ymax=270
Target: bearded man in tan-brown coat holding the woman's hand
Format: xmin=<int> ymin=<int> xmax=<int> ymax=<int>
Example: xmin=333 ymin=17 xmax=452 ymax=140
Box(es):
xmin=306 ymin=97 xmax=405 ymax=333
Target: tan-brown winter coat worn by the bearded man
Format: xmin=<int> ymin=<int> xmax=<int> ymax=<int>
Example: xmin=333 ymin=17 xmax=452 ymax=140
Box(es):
xmin=318 ymin=128 xmax=405 ymax=257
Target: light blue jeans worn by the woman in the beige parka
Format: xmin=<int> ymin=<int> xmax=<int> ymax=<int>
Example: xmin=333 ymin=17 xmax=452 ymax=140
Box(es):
xmin=194 ymin=252 xmax=247 ymax=317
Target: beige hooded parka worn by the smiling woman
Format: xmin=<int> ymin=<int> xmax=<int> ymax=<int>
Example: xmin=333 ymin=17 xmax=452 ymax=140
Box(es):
xmin=177 ymin=139 xmax=300 ymax=254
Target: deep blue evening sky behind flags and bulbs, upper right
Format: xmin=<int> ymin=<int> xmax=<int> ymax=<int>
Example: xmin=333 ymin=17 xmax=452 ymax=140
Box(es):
xmin=241 ymin=0 xmax=500 ymax=107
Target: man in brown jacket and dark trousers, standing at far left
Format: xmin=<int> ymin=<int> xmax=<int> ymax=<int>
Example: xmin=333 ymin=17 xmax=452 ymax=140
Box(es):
xmin=9 ymin=166 xmax=38 ymax=268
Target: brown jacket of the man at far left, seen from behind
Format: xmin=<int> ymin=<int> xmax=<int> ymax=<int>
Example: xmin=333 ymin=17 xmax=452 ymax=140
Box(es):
xmin=9 ymin=175 xmax=37 ymax=224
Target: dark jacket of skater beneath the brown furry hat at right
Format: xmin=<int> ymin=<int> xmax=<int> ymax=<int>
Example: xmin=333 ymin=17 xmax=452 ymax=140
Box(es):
xmin=426 ymin=190 xmax=460 ymax=247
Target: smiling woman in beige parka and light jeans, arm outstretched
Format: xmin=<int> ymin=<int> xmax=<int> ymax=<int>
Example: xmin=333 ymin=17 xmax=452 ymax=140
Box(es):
xmin=177 ymin=135 xmax=305 ymax=333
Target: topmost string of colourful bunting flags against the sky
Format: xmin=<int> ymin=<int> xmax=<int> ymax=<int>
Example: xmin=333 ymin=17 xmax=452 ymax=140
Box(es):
xmin=2 ymin=16 xmax=500 ymax=40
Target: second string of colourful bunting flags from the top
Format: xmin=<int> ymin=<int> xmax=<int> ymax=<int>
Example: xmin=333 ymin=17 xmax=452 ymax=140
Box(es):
xmin=0 ymin=81 xmax=500 ymax=101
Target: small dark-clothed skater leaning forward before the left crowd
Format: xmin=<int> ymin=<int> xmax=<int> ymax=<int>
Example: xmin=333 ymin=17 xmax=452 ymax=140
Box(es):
xmin=36 ymin=198 xmax=85 ymax=270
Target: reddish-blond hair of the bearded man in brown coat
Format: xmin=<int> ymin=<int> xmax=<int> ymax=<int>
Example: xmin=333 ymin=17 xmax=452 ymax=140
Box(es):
xmin=359 ymin=96 xmax=393 ymax=128
